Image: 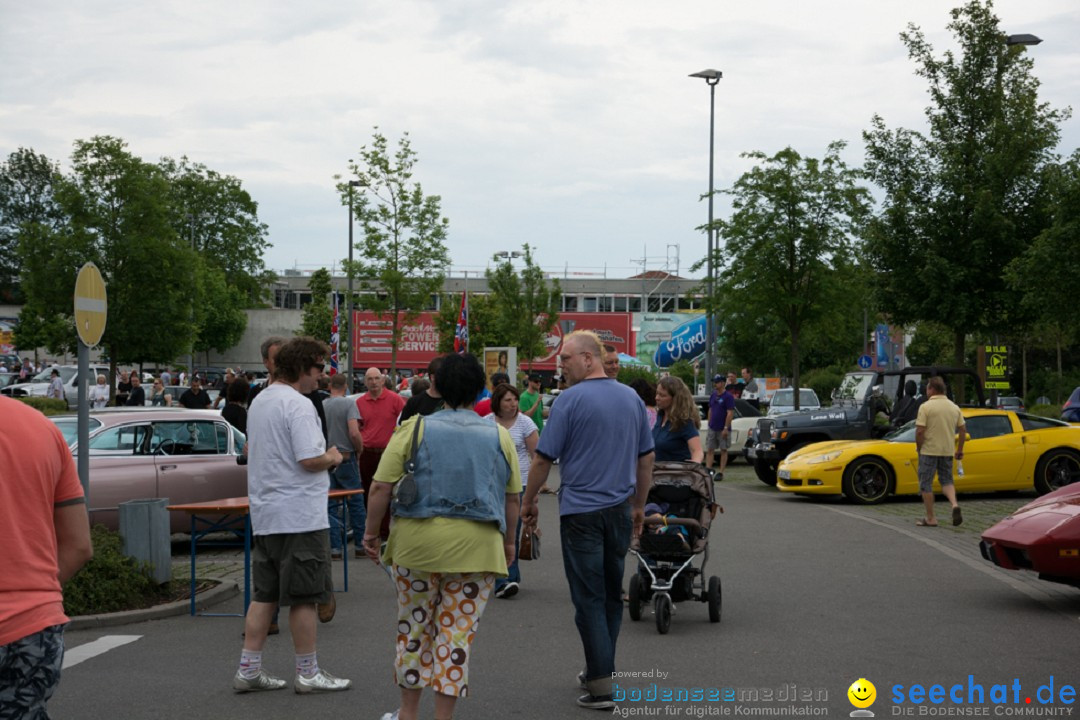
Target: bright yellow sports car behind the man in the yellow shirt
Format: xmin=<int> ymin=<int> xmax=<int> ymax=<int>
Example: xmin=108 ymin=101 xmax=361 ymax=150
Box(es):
xmin=777 ymin=408 xmax=1080 ymax=505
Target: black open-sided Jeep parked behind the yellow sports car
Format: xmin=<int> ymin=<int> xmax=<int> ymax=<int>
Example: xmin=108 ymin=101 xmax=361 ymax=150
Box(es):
xmin=747 ymin=366 xmax=985 ymax=485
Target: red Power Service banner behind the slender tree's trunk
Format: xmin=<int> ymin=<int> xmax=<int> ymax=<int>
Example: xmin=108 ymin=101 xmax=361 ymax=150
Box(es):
xmin=352 ymin=310 xmax=438 ymax=369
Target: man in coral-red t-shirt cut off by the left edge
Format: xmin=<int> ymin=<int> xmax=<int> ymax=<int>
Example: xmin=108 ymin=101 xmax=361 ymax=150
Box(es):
xmin=0 ymin=397 xmax=93 ymax=718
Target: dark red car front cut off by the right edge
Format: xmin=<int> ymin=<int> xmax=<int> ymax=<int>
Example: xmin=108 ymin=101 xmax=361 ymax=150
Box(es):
xmin=978 ymin=483 xmax=1080 ymax=587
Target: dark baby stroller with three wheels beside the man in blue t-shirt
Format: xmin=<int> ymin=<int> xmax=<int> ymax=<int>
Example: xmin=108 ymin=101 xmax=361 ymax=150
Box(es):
xmin=629 ymin=462 xmax=724 ymax=635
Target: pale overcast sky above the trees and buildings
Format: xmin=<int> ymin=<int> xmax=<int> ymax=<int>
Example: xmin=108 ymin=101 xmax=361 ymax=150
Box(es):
xmin=0 ymin=0 xmax=1080 ymax=277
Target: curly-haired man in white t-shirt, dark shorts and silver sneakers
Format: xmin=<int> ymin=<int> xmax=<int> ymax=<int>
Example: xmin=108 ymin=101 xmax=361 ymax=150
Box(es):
xmin=232 ymin=338 xmax=352 ymax=694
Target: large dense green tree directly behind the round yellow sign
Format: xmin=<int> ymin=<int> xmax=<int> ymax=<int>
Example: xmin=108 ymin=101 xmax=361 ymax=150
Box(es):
xmin=15 ymin=136 xmax=198 ymax=377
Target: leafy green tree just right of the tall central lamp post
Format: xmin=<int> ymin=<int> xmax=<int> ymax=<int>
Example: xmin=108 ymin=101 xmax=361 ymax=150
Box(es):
xmin=713 ymin=142 xmax=868 ymax=402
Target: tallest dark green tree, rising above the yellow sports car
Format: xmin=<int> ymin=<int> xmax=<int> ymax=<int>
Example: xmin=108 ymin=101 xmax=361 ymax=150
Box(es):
xmin=863 ymin=0 xmax=1069 ymax=364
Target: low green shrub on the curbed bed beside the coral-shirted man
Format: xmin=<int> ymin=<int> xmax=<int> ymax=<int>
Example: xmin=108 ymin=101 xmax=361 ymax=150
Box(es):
xmin=64 ymin=525 xmax=162 ymax=616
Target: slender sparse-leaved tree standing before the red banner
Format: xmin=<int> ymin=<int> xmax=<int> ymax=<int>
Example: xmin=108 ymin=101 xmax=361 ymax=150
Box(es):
xmin=337 ymin=127 xmax=450 ymax=375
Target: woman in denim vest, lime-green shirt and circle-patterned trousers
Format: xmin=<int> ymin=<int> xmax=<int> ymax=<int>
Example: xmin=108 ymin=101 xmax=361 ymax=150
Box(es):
xmin=364 ymin=355 xmax=522 ymax=720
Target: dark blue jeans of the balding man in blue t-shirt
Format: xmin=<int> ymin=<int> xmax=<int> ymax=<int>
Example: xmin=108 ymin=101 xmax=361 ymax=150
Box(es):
xmin=559 ymin=501 xmax=632 ymax=695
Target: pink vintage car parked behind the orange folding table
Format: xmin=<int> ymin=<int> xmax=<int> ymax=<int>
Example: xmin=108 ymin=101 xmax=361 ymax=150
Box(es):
xmin=50 ymin=408 xmax=247 ymax=532
